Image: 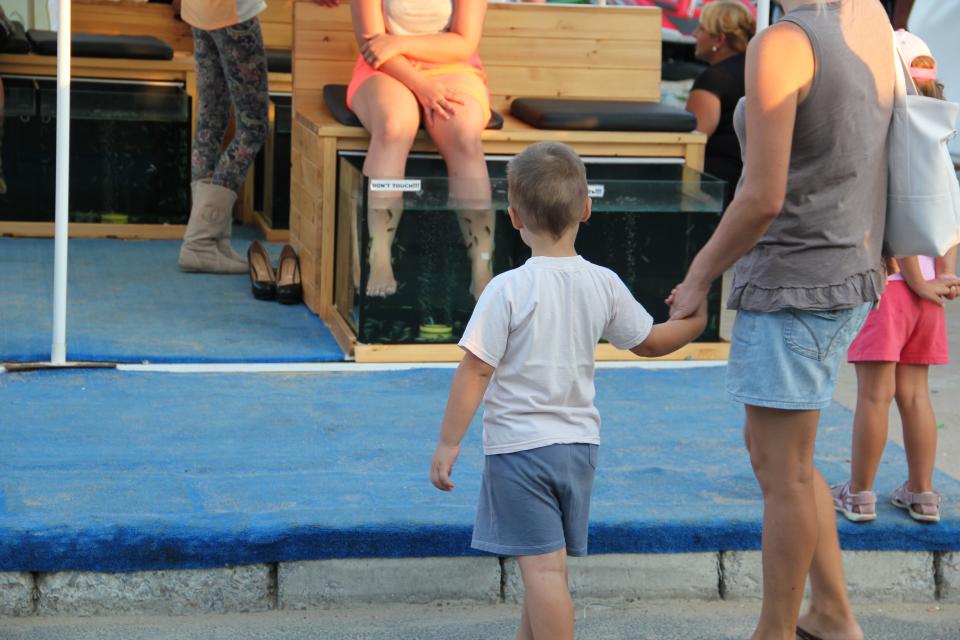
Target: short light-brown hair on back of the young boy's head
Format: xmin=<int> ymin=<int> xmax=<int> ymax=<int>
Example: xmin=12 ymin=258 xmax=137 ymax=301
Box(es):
xmin=507 ymin=142 xmax=587 ymax=239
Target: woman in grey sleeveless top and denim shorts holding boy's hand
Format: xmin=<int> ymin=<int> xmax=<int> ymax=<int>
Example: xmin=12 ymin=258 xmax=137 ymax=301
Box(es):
xmin=667 ymin=0 xmax=893 ymax=640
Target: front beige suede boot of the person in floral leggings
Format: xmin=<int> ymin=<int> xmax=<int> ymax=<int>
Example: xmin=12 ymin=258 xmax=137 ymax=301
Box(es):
xmin=179 ymin=180 xmax=247 ymax=273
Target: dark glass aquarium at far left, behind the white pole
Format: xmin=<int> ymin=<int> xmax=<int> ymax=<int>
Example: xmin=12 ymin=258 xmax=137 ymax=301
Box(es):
xmin=0 ymin=77 xmax=191 ymax=224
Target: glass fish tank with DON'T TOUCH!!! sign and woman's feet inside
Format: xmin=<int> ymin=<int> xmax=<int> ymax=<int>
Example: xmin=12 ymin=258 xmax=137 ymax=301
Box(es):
xmin=334 ymin=152 xmax=726 ymax=344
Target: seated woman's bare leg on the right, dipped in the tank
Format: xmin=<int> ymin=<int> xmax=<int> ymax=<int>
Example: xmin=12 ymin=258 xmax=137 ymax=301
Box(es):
xmin=428 ymin=75 xmax=496 ymax=298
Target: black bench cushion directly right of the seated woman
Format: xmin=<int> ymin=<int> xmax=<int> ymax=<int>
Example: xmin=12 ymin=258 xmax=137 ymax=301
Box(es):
xmin=510 ymin=98 xmax=697 ymax=131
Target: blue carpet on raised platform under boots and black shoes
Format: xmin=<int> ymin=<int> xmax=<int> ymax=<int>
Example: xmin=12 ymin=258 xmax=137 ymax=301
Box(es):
xmin=0 ymin=238 xmax=343 ymax=363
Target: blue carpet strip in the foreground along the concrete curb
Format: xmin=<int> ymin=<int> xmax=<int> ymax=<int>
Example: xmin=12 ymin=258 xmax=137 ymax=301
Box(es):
xmin=0 ymin=368 xmax=960 ymax=571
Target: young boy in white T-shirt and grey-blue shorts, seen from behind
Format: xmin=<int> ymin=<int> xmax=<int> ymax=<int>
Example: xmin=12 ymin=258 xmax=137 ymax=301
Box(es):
xmin=430 ymin=142 xmax=706 ymax=640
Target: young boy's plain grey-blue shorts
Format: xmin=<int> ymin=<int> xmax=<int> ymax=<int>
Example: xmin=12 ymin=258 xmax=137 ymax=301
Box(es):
xmin=470 ymin=444 xmax=599 ymax=556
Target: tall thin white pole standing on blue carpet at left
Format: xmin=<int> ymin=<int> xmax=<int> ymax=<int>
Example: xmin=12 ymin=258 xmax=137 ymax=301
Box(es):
xmin=50 ymin=0 xmax=71 ymax=364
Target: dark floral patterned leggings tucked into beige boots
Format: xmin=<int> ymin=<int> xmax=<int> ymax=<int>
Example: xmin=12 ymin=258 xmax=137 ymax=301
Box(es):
xmin=190 ymin=18 xmax=269 ymax=191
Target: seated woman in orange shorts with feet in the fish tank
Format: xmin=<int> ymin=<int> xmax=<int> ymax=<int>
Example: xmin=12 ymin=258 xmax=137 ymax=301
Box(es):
xmin=347 ymin=0 xmax=494 ymax=297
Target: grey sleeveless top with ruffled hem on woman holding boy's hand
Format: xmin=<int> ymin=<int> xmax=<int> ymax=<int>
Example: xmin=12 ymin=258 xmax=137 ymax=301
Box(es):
xmin=727 ymin=0 xmax=893 ymax=311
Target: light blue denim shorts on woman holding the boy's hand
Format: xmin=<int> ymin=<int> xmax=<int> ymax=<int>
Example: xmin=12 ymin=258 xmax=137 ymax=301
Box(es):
xmin=727 ymin=302 xmax=873 ymax=410
